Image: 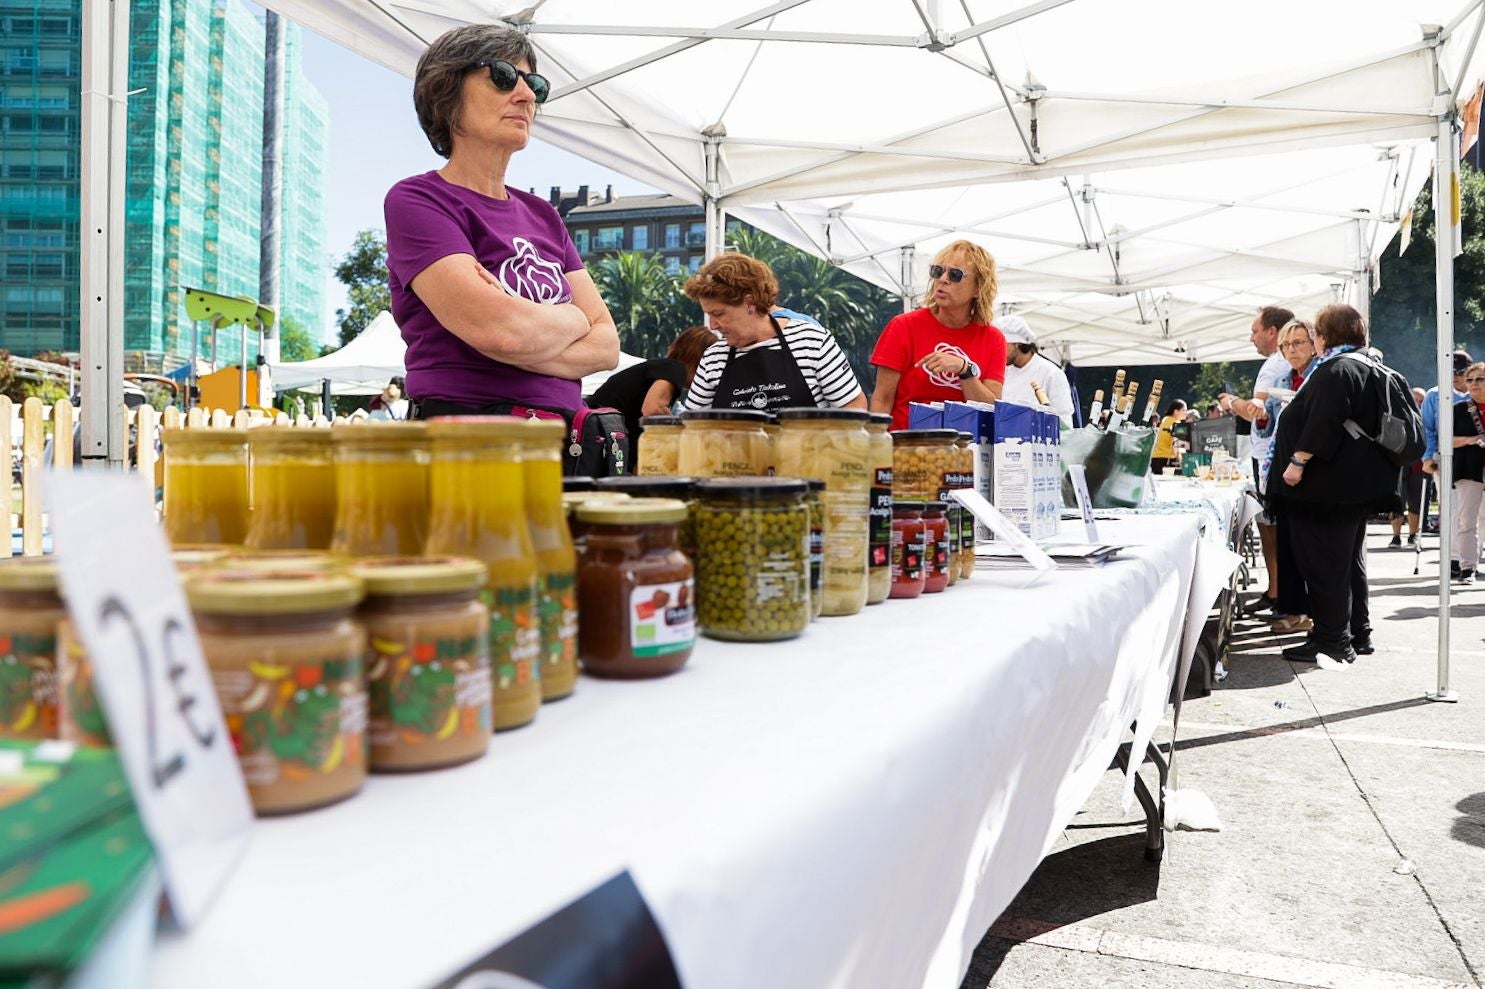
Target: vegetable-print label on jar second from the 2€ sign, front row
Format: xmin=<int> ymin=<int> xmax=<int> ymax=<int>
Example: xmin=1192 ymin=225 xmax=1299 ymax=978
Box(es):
xmin=367 ymin=636 xmax=493 ymax=747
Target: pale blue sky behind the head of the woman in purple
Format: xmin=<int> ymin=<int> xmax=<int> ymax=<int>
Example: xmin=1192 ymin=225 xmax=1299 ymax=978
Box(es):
xmin=291 ymin=22 xmax=655 ymax=340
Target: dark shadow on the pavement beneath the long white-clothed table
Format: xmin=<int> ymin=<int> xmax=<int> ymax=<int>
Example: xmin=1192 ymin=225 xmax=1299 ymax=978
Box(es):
xmin=962 ymin=821 xmax=1160 ymax=988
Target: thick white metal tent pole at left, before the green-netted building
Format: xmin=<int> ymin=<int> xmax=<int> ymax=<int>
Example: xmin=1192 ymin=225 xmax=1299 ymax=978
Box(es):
xmin=79 ymin=0 xmax=129 ymax=469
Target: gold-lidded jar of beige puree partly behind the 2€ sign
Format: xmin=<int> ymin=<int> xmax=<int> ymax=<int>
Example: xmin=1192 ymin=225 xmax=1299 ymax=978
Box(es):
xmin=186 ymin=570 xmax=367 ymax=815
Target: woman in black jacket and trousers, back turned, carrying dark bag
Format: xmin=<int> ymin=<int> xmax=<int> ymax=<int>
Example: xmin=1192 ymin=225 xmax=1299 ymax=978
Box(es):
xmin=1268 ymin=306 xmax=1397 ymax=668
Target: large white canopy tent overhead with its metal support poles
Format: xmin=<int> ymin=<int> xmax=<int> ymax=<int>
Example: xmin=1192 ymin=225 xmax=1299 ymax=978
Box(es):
xmin=82 ymin=0 xmax=1485 ymax=709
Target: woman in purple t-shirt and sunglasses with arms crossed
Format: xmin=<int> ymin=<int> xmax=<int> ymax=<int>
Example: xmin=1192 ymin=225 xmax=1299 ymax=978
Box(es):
xmin=386 ymin=24 xmax=619 ymax=417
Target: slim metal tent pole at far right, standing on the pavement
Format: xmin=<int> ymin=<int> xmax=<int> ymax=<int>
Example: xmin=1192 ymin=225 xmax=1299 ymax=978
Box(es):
xmin=1427 ymin=111 xmax=1461 ymax=702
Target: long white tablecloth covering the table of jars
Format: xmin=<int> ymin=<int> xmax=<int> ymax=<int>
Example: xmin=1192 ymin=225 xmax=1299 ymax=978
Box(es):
xmin=151 ymin=515 xmax=1209 ymax=989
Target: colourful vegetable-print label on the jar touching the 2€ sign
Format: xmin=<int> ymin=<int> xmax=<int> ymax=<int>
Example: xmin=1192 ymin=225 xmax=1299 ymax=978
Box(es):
xmin=211 ymin=656 xmax=367 ymax=786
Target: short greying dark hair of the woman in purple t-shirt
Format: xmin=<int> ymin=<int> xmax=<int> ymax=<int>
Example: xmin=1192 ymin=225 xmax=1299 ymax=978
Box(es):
xmin=413 ymin=24 xmax=536 ymax=157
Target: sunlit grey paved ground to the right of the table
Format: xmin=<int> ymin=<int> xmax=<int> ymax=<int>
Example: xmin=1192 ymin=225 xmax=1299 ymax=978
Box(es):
xmin=962 ymin=526 xmax=1485 ymax=989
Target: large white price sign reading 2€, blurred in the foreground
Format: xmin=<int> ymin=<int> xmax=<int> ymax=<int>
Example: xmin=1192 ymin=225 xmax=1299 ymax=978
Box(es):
xmin=46 ymin=471 xmax=252 ymax=927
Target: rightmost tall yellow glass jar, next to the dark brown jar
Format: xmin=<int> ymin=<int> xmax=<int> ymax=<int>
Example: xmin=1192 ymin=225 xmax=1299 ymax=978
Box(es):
xmin=521 ymin=419 xmax=578 ymax=702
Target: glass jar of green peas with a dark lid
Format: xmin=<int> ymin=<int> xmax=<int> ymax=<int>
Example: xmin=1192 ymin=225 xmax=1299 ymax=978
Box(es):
xmin=696 ymin=477 xmax=811 ymax=642
